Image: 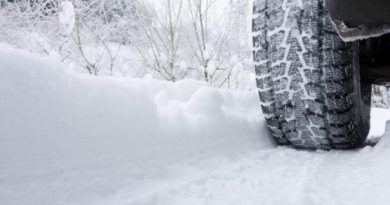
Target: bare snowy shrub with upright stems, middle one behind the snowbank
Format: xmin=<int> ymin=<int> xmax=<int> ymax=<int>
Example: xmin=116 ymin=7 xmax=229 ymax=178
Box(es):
xmin=137 ymin=0 xmax=188 ymax=81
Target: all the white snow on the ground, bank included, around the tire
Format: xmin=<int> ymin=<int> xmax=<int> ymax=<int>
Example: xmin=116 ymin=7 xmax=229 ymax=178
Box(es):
xmin=0 ymin=45 xmax=390 ymax=205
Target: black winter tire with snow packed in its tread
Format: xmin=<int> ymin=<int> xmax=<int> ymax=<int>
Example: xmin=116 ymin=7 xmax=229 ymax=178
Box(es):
xmin=252 ymin=0 xmax=371 ymax=149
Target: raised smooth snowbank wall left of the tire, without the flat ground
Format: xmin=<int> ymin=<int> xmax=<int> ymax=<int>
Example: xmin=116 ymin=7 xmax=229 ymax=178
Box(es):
xmin=0 ymin=45 xmax=270 ymax=162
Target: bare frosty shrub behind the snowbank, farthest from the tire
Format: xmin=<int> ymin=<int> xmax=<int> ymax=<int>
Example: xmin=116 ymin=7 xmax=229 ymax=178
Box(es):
xmin=69 ymin=0 xmax=129 ymax=75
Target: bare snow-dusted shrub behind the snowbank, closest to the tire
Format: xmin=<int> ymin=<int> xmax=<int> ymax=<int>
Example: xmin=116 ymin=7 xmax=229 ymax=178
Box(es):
xmin=187 ymin=0 xmax=249 ymax=87
